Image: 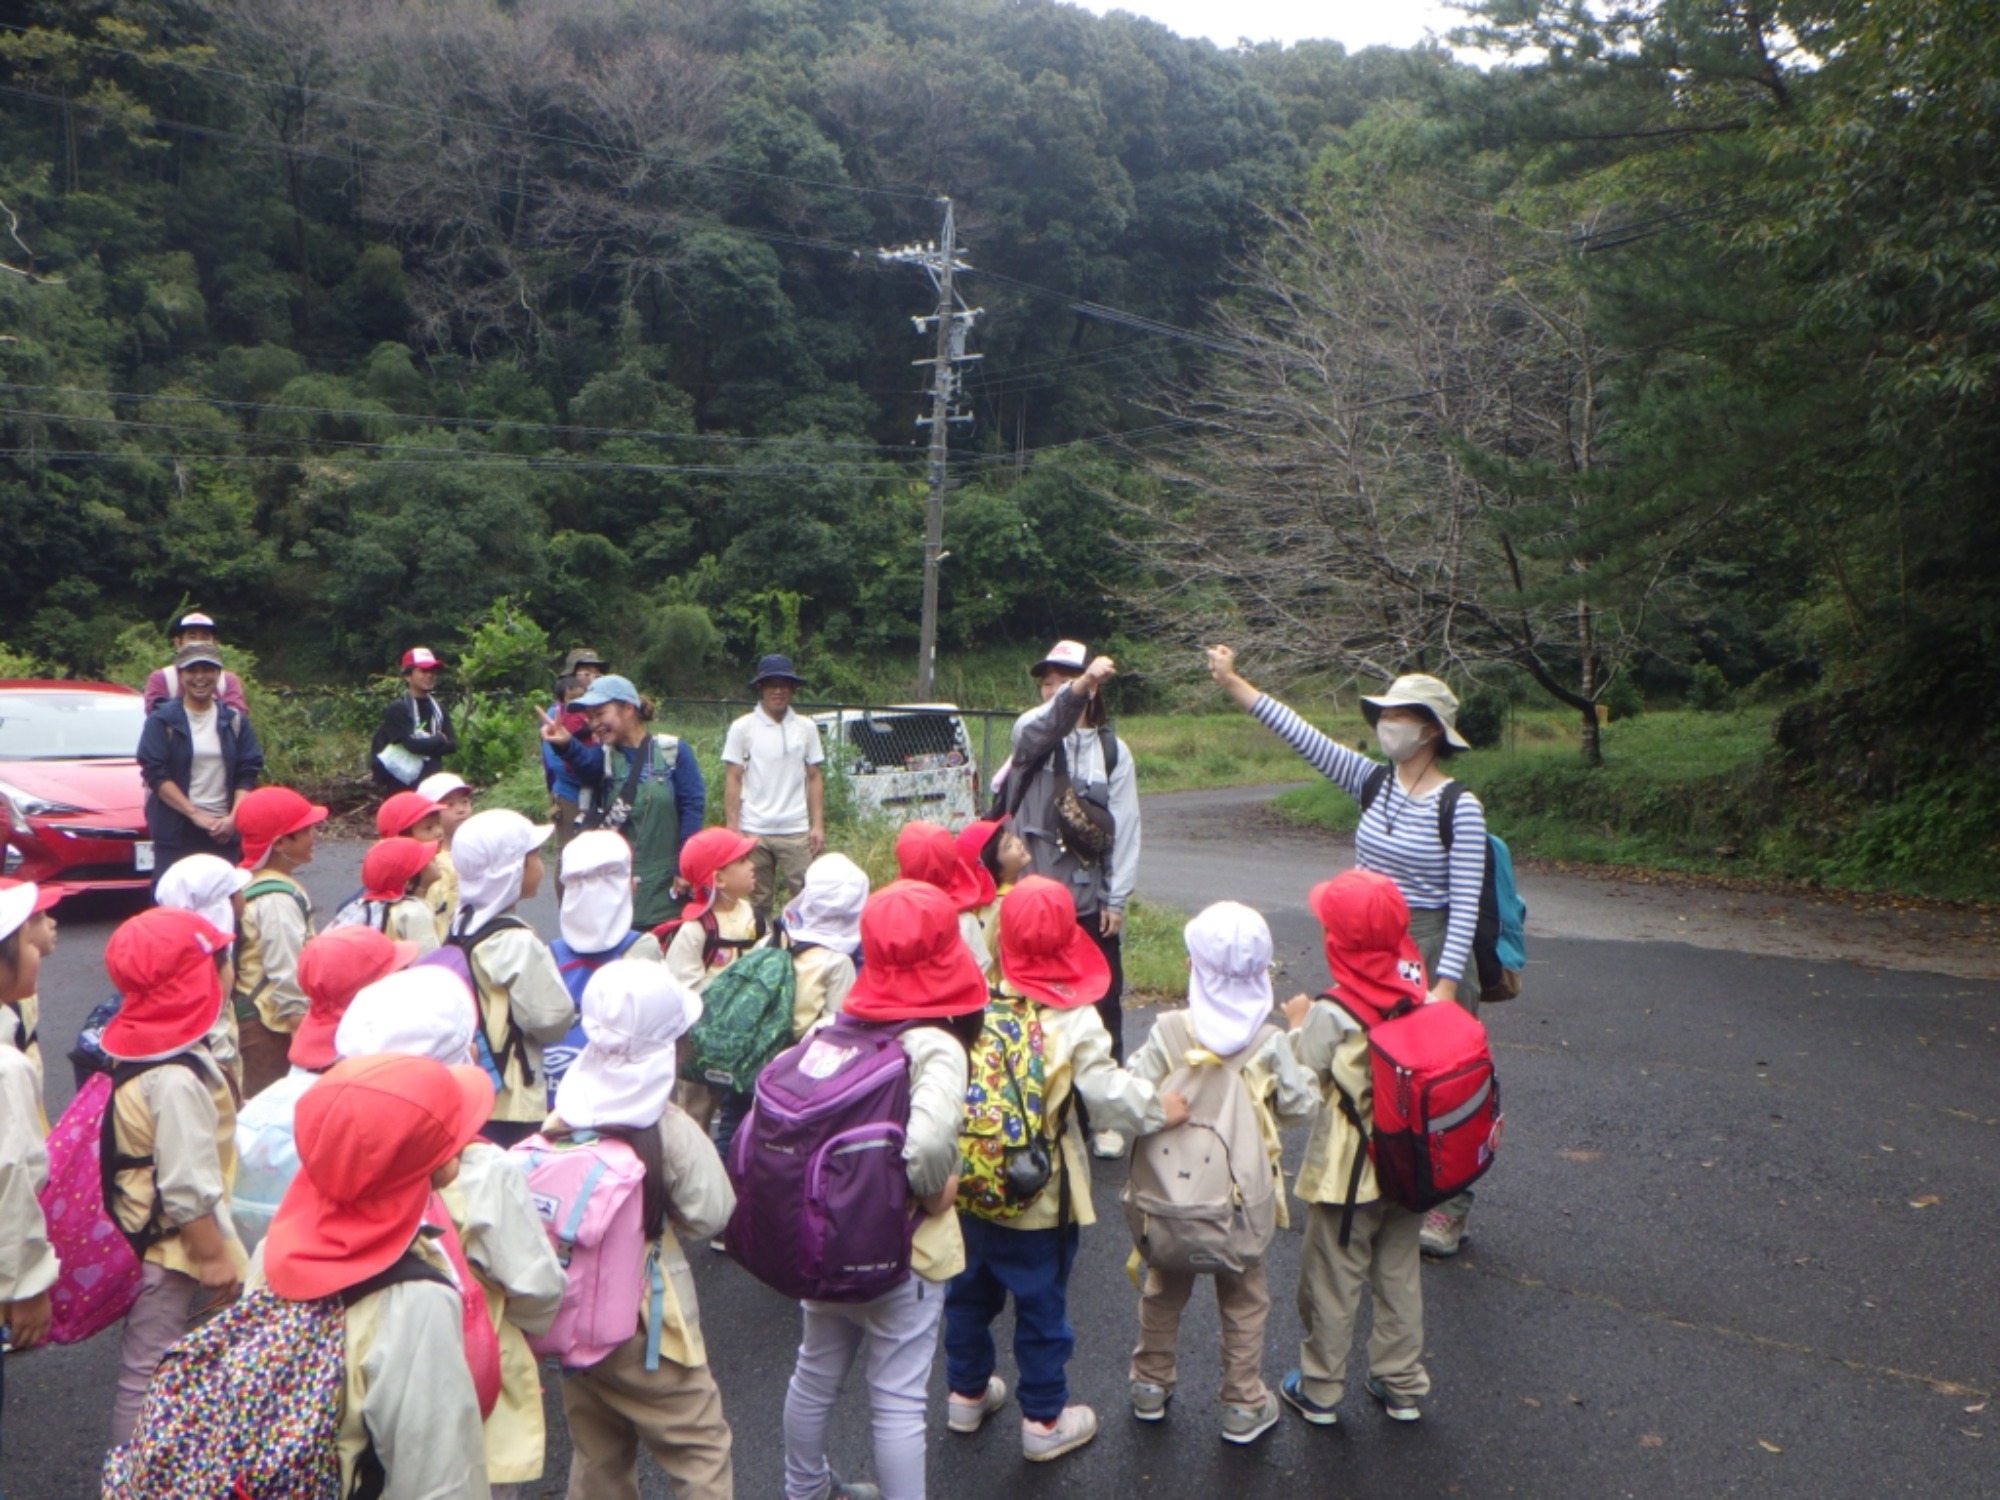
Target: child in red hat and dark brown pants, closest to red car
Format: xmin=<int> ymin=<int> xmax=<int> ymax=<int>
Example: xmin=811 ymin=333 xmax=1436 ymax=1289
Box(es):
xmin=232 ymin=786 xmax=326 ymax=1100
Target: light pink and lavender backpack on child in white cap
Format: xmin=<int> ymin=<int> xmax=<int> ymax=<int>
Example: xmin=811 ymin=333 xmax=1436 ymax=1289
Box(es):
xmin=512 ymin=1130 xmax=666 ymax=1370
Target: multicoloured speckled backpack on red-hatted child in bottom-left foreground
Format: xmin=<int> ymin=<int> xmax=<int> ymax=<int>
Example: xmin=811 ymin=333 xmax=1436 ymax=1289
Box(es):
xmin=104 ymin=1256 xmax=450 ymax=1500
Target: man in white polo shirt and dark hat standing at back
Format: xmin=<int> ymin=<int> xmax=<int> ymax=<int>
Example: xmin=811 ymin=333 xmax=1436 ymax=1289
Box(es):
xmin=722 ymin=656 xmax=826 ymax=922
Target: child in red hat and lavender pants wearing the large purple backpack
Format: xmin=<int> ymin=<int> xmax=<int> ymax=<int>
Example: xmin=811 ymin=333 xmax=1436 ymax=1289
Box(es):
xmin=784 ymin=880 xmax=986 ymax=1500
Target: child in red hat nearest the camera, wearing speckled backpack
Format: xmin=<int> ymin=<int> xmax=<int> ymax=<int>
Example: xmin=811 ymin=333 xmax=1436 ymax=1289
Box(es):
xmin=252 ymin=1056 xmax=494 ymax=1500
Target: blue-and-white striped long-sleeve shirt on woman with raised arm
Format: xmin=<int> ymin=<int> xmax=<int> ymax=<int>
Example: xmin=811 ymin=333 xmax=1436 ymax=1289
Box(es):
xmin=1250 ymin=694 xmax=1486 ymax=980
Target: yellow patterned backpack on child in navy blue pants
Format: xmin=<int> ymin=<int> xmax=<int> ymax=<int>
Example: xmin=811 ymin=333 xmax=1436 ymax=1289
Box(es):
xmin=958 ymin=996 xmax=1050 ymax=1222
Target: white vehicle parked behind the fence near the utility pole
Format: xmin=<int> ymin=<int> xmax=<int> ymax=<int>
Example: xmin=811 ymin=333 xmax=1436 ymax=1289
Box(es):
xmin=812 ymin=704 xmax=980 ymax=832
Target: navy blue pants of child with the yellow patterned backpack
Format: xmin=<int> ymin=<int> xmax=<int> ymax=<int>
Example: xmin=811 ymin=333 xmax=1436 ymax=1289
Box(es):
xmin=944 ymin=1214 xmax=1078 ymax=1422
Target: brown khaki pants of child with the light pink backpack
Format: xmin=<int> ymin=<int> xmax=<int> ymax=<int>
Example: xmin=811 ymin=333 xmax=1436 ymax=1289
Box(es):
xmin=562 ymin=1330 xmax=736 ymax=1500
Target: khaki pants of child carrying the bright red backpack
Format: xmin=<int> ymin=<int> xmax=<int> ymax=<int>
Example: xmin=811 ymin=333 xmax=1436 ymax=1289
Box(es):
xmin=1298 ymin=1202 xmax=1430 ymax=1406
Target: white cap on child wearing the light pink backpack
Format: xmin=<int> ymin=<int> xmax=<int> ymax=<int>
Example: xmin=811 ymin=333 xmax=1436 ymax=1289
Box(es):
xmin=556 ymin=958 xmax=702 ymax=1130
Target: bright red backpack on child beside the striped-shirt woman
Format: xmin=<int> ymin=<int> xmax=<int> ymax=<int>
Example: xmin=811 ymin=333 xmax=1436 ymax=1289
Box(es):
xmin=1320 ymin=990 xmax=1502 ymax=1246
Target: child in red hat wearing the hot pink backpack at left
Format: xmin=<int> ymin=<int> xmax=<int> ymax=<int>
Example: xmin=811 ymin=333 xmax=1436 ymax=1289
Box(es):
xmin=100 ymin=906 xmax=246 ymax=1446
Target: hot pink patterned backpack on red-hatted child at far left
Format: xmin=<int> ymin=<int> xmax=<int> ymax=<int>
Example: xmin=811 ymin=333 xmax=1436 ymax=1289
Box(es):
xmin=38 ymin=1072 xmax=140 ymax=1344
